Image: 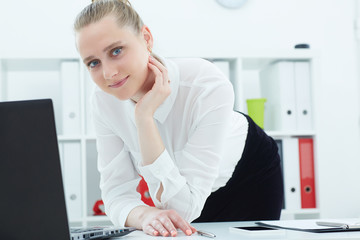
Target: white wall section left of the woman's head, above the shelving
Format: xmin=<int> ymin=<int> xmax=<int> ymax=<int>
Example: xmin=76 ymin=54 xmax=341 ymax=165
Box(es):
xmin=0 ymin=0 xmax=82 ymax=58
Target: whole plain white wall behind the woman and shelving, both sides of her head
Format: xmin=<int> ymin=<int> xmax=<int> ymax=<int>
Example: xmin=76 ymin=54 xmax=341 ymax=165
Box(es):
xmin=0 ymin=0 xmax=360 ymax=217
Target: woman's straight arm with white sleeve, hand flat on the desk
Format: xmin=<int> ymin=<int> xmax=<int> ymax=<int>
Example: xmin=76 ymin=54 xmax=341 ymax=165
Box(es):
xmin=93 ymin=95 xmax=196 ymax=236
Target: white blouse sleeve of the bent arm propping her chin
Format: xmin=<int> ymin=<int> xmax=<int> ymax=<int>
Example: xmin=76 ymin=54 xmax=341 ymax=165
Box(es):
xmin=140 ymin=73 xmax=234 ymax=222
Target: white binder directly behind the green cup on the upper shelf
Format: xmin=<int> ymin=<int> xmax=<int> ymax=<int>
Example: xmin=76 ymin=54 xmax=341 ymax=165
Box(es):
xmin=260 ymin=61 xmax=297 ymax=131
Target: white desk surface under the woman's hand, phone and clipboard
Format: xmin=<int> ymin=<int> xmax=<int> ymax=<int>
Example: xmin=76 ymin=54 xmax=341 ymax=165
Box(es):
xmin=117 ymin=222 xmax=360 ymax=240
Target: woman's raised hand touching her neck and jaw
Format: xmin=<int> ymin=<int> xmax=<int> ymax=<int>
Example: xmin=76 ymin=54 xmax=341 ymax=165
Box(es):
xmin=135 ymin=56 xmax=171 ymax=118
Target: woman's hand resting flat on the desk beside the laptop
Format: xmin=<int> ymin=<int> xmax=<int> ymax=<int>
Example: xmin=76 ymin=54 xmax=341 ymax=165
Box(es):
xmin=141 ymin=208 xmax=196 ymax=237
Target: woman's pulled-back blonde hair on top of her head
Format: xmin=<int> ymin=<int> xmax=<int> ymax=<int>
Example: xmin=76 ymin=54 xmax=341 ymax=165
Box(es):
xmin=74 ymin=0 xmax=144 ymax=34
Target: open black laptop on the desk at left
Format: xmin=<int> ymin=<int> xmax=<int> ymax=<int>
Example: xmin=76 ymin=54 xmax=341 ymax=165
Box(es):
xmin=0 ymin=99 xmax=135 ymax=240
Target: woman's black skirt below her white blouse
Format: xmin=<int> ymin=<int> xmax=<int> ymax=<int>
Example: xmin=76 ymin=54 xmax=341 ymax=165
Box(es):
xmin=193 ymin=114 xmax=284 ymax=222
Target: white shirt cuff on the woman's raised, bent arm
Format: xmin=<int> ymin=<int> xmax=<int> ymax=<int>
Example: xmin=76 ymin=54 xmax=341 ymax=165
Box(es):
xmin=139 ymin=149 xmax=175 ymax=184
